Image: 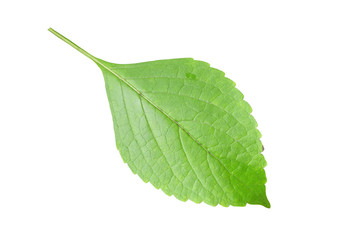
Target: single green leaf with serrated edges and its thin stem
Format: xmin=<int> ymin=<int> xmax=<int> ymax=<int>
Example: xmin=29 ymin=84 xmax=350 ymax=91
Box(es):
xmin=49 ymin=28 xmax=270 ymax=207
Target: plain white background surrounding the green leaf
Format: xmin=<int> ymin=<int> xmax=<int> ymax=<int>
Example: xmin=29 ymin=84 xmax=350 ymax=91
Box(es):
xmin=0 ymin=0 xmax=360 ymax=240
